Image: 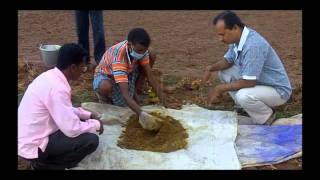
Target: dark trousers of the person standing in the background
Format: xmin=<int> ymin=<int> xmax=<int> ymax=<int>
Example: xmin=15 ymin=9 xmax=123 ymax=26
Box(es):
xmin=75 ymin=11 xmax=106 ymax=64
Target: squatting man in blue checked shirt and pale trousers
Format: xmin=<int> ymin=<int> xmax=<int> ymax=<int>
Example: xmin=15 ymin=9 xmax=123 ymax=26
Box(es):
xmin=203 ymin=11 xmax=292 ymax=125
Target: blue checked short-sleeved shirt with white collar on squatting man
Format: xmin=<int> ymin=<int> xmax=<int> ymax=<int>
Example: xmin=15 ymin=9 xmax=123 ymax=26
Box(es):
xmin=224 ymin=27 xmax=292 ymax=100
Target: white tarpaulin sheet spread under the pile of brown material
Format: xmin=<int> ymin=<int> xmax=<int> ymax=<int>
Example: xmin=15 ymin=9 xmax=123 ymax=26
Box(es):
xmin=75 ymin=103 xmax=241 ymax=169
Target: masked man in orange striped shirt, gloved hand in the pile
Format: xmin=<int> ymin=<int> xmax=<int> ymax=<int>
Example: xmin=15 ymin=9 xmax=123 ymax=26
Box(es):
xmin=93 ymin=28 xmax=165 ymax=130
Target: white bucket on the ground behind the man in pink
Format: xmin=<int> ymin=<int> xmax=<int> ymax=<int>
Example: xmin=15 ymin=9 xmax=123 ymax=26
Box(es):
xmin=39 ymin=45 xmax=61 ymax=68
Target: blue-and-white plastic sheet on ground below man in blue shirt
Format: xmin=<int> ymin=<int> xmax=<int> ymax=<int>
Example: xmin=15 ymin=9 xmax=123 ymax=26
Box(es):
xmin=236 ymin=114 xmax=302 ymax=167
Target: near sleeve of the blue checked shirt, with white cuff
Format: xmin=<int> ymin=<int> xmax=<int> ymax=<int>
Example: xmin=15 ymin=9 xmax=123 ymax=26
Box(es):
xmin=241 ymin=47 xmax=266 ymax=80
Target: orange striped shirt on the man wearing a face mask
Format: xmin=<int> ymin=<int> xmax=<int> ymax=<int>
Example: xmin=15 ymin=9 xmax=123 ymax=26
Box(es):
xmin=95 ymin=40 xmax=149 ymax=83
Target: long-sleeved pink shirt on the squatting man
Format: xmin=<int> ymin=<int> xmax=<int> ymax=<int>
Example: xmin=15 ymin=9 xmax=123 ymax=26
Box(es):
xmin=18 ymin=68 xmax=100 ymax=159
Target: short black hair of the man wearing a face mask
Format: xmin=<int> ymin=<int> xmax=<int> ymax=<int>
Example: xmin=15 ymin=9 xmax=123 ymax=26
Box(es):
xmin=128 ymin=28 xmax=151 ymax=48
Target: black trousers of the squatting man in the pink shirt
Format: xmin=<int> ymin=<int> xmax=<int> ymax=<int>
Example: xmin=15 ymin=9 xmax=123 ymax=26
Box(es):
xmin=30 ymin=130 xmax=99 ymax=170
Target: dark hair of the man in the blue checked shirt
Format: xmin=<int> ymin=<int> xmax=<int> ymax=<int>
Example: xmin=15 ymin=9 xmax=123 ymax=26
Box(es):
xmin=213 ymin=11 xmax=245 ymax=29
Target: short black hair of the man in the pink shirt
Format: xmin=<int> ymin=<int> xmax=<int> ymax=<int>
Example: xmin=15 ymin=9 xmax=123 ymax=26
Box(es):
xmin=56 ymin=43 xmax=88 ymax=70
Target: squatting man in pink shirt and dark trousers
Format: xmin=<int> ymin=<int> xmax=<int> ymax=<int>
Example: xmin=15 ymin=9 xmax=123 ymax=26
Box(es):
xmin=18 ymin=43 xmax=103 ymax=170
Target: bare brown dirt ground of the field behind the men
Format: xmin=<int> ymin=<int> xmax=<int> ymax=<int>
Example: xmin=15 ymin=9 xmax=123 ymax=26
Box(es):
xmin=18 ymin=10 xmax=302 ymax=170
